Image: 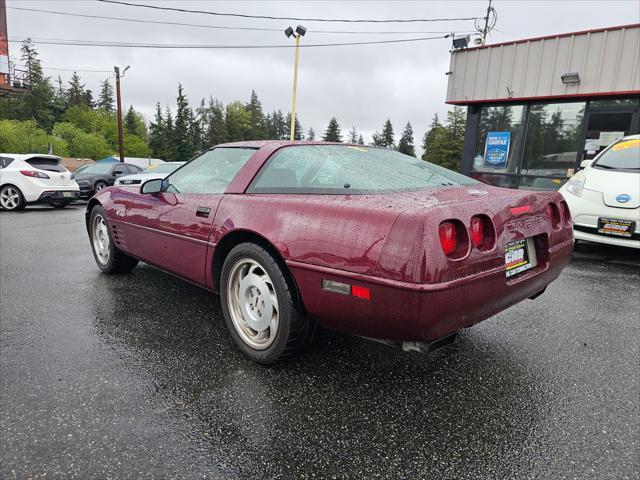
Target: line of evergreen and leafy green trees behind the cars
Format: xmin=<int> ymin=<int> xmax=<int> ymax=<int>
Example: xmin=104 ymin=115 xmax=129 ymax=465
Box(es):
xmin=0 ymin=40 xmax=465 ymax=169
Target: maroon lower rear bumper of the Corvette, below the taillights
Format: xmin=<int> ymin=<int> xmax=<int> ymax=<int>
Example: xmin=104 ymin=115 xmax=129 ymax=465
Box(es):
xmin=287 ymin=240 xmax=573 ymax=342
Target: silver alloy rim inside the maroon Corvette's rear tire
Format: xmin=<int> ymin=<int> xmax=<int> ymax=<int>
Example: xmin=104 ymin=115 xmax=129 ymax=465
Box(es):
xmin=227 ymin=258 xmax=280 ymax=350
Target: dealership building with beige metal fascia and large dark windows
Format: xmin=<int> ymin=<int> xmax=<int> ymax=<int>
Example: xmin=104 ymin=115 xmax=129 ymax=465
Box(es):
xmin=447 ymin=24 xmax=640 ymax=190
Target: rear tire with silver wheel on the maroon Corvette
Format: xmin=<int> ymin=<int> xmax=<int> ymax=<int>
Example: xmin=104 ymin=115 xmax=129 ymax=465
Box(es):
xmin=220 ymin=243 xmax=314 ymax=364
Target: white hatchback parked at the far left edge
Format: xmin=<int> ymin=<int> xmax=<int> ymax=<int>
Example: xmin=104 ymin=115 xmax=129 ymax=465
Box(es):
xmin=0 ymin=153 xmax=80 ymax=210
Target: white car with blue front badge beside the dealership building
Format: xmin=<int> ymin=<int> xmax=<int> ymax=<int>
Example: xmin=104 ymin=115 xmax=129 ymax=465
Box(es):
xmin=560 ymin=135 xmax=640 ymax=248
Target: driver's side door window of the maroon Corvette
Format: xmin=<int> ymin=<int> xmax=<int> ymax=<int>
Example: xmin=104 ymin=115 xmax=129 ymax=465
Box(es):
xmin=165 ymin=147 xmax=255 ymax=193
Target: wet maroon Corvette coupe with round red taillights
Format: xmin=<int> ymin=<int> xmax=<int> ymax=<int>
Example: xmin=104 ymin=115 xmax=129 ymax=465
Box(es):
xmin=86 ymin=141 xmax=573 ymax=363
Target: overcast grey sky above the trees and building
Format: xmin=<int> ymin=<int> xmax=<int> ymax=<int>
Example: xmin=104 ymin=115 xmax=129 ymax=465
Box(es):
xmin=7 ymin=0 xmax=640 ymax=150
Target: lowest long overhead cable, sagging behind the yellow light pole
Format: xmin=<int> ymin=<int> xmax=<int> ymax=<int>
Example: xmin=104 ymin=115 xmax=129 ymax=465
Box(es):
xmin=9 ymin=34 xmax=450 ymax=50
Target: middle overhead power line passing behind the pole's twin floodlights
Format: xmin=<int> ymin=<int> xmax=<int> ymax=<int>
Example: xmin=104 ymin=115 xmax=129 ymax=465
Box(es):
xmin=7 ymin=7 xmax=476 ymax=35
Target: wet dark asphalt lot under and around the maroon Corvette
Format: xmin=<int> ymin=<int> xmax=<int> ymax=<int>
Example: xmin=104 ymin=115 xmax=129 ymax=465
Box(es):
xmin=0 ymin=205 xmax=640 ymax=479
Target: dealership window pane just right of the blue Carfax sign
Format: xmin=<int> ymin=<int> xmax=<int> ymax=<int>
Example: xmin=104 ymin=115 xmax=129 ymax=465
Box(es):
xmin=521 ymin=102 xmax=585 ymax=177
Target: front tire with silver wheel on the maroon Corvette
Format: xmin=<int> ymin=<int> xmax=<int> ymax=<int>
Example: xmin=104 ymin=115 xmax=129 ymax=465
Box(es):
xmin=89 ymin=205 xmax=138 ymax=274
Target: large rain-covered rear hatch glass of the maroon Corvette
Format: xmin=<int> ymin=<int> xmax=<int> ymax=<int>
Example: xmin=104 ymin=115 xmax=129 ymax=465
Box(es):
xmin=248 ymin=145 xmax=478 ymax=195
